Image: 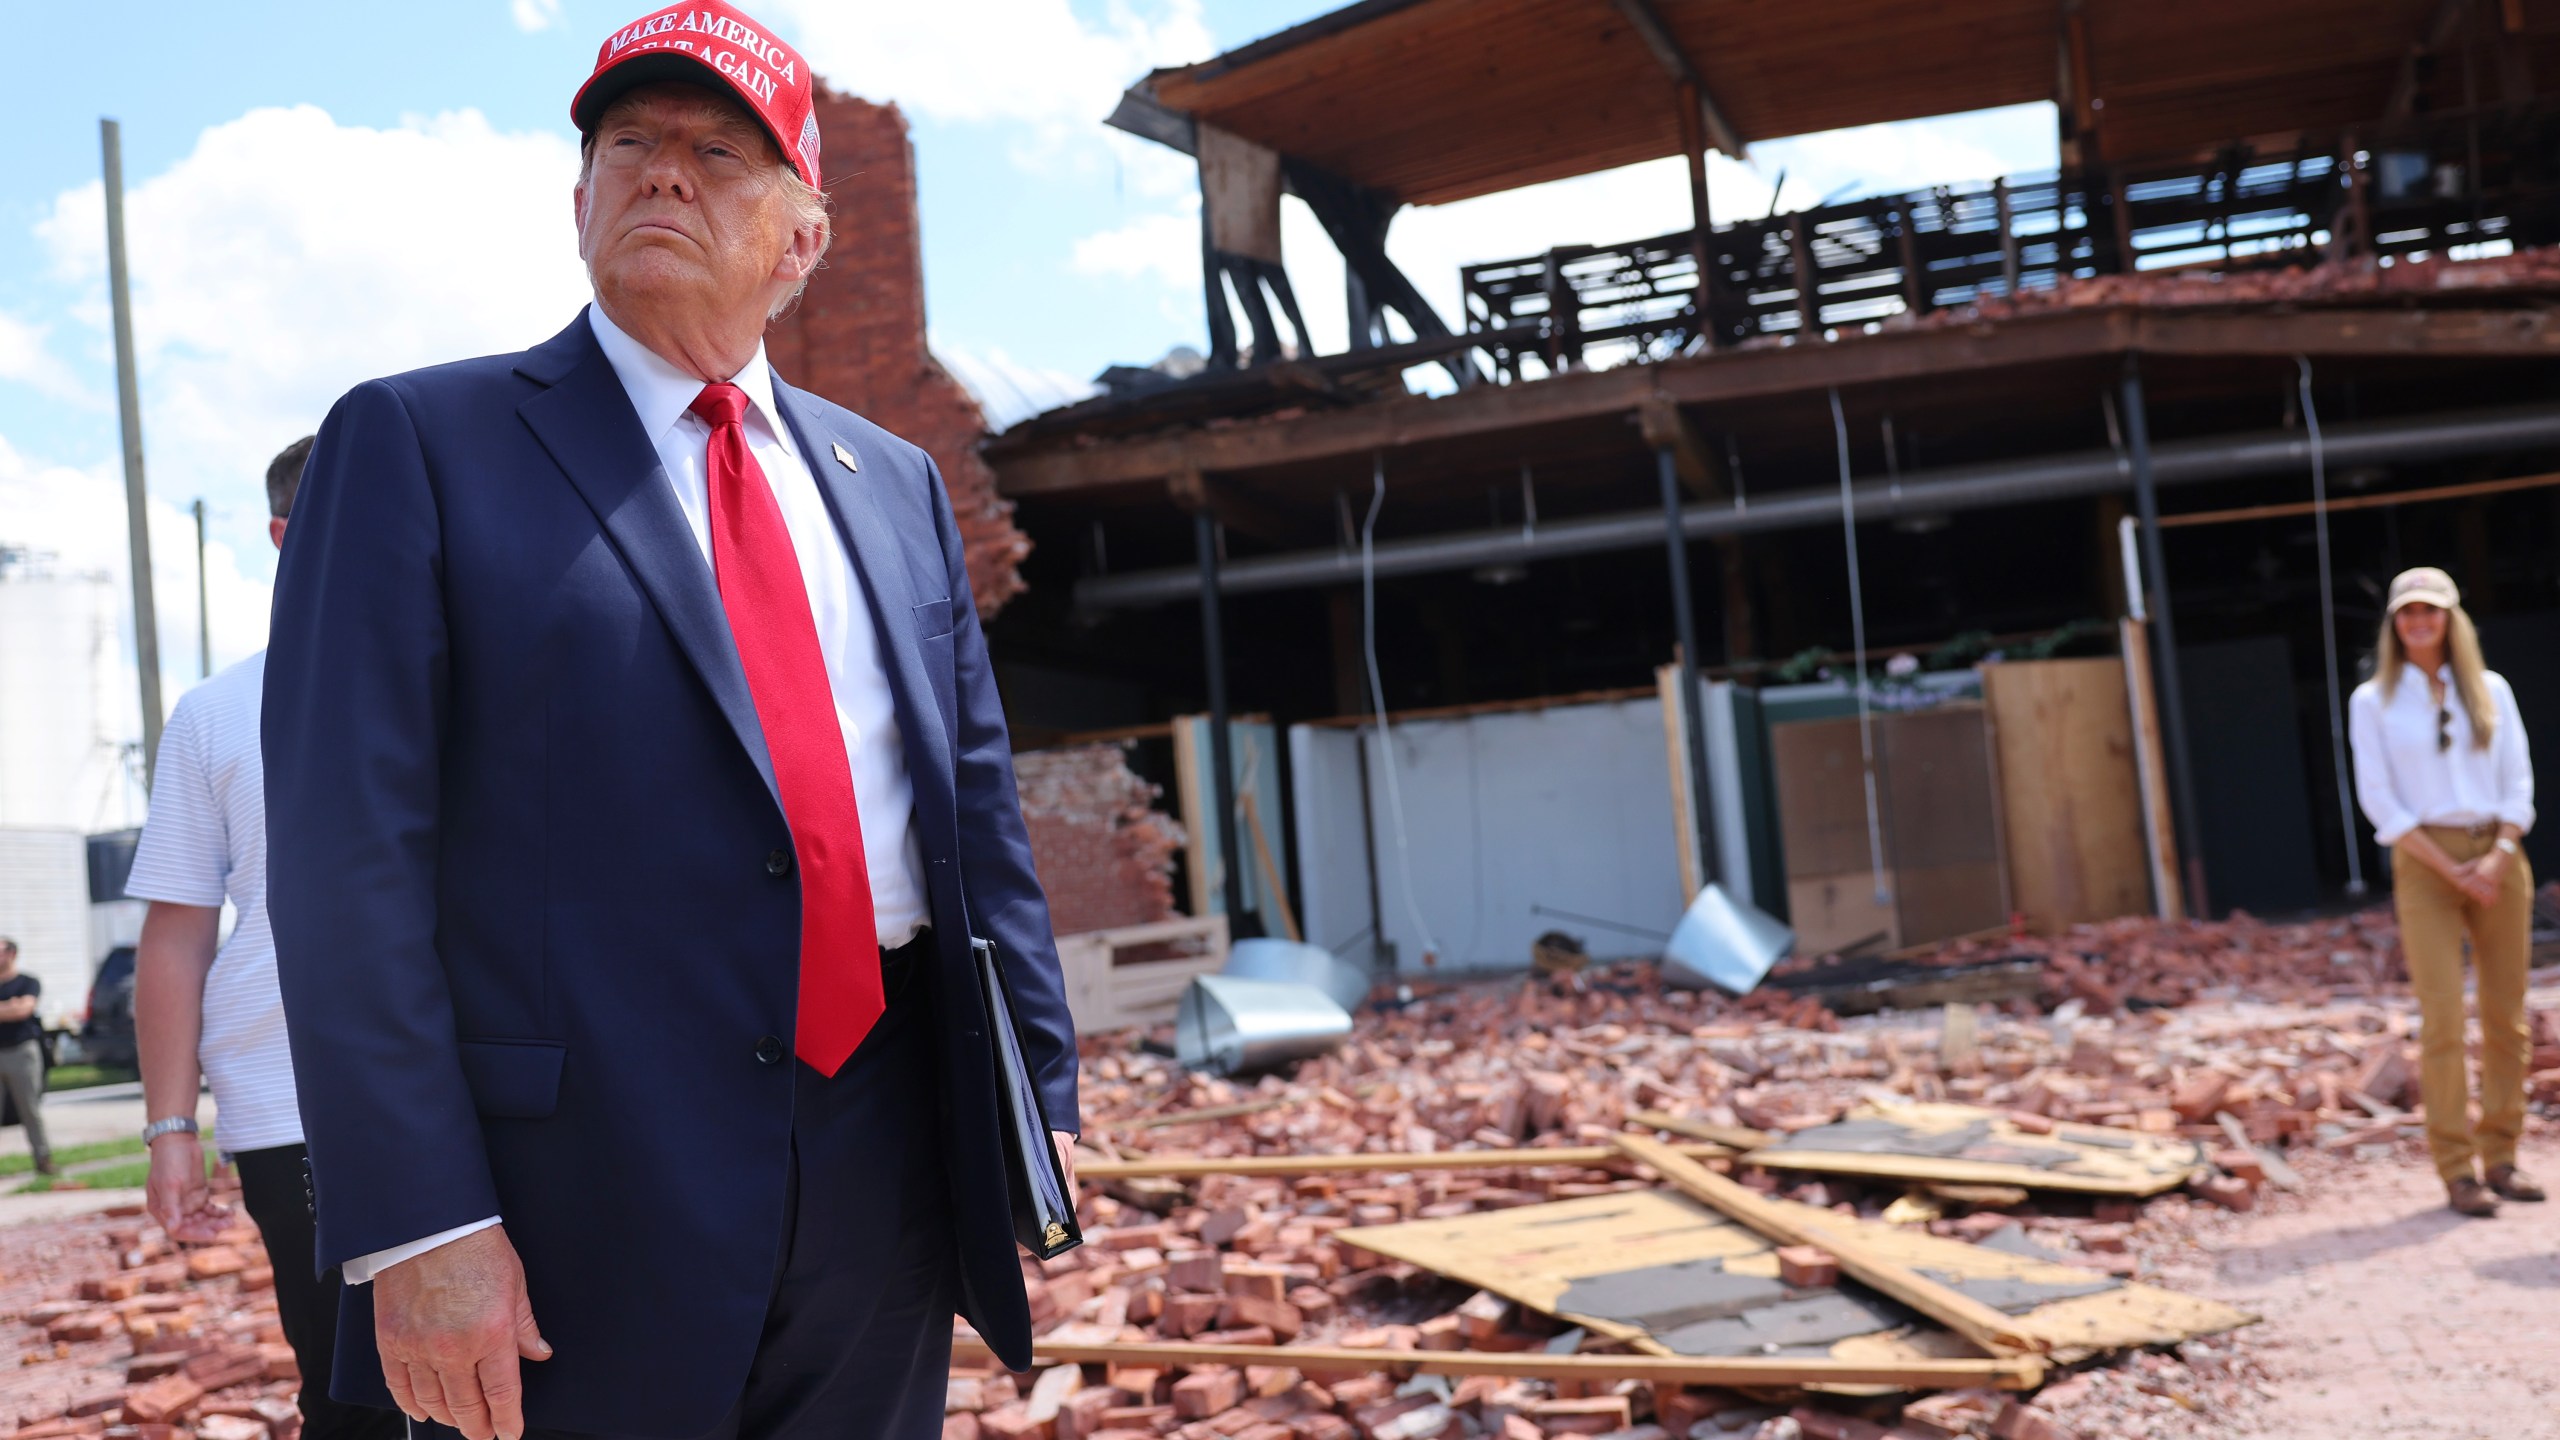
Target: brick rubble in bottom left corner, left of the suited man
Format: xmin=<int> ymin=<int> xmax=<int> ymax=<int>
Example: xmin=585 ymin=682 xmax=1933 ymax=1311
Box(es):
xmin=0 ymin=1173 xmax=302 ymax=1440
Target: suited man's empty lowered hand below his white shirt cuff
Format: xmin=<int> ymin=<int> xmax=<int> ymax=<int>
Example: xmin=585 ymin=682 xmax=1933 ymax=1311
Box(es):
xmin=374 ymin=1225 xmax=550 ymax=1440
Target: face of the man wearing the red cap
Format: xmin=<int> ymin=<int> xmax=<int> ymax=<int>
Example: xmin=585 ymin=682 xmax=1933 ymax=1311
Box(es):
xmin=576 ymin=85 xmax=817 ymax=320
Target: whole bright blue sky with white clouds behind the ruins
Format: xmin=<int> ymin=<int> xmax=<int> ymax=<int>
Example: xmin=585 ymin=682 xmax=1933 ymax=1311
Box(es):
xmin=0 ymin=0 xmax=2053 ymax=717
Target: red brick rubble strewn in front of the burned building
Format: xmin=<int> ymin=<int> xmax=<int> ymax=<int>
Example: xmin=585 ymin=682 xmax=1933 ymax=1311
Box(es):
xmin=945 ymin=942 xmax=2519 ymax=1440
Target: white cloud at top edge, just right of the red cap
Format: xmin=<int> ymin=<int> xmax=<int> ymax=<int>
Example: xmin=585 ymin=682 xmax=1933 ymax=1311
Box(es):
xmin=765 ymin=0 xmax=1219 ymax=138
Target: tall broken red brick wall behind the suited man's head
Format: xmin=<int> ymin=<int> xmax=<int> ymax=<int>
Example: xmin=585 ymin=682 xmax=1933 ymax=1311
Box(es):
xmin=765 ymin=85 xmax=1032 ymax=618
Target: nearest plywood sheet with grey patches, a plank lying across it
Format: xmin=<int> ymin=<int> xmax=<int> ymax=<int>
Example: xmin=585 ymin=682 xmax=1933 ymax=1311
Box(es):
xmin=1339 ymin=1191 xmax=2250 ymax=1361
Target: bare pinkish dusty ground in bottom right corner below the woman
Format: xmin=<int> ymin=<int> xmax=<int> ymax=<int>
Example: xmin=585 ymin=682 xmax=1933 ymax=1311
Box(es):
xmin=2179 ymin=1140 xmax=2560 ymax=1440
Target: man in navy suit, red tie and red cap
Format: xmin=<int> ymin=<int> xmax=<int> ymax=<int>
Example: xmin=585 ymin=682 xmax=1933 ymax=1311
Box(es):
xmin=264 ymin=3 xmax=1075 ymax=1440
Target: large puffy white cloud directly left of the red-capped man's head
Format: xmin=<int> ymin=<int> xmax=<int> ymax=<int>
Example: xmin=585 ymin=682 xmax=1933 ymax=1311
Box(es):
xmin=38 ymin=105 xmax=586 ymax=556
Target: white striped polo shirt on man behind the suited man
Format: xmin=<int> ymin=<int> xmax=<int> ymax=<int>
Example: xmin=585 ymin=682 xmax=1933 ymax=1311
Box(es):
xmin=125 ymin=651 xmax=302 ymax=1153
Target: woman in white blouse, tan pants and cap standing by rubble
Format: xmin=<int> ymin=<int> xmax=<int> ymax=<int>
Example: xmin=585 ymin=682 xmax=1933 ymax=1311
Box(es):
xmin=2348 ymin=569 xmax=2542 ymax=1215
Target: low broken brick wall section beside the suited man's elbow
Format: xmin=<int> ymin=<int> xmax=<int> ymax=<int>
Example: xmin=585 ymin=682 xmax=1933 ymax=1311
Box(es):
xmin=1014 ymin=746 xmax=1183 ymax=935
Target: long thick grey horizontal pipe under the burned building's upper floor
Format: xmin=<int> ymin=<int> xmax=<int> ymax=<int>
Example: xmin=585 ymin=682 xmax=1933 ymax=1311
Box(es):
xmin=1075 ymin=405 xmax=2560 ymax=610
